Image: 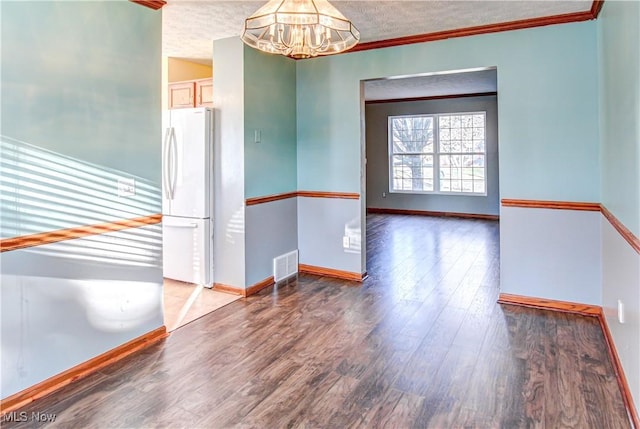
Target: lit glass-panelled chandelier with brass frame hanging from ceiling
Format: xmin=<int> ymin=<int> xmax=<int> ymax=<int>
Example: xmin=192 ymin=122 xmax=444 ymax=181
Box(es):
xmin=241 ymin=0 xmax=360 ymax=59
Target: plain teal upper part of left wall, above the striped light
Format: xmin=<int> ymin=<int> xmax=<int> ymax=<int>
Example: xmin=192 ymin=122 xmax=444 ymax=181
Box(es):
xmin=0 ymin=1 xmax=162 ymax=183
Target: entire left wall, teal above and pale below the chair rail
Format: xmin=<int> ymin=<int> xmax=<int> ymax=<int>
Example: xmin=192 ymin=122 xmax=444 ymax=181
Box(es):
xmin=0 ymin=1 xmax=163 ymax=398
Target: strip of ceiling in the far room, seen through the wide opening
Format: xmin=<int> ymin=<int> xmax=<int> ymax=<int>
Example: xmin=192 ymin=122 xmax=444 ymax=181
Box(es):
xmin=364 ymin=69 xmax=498 ymax=101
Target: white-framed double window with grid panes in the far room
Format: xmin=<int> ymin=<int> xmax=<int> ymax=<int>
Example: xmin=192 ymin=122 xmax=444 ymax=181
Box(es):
xmin=389 ymin=112 xmax=487 ymax=195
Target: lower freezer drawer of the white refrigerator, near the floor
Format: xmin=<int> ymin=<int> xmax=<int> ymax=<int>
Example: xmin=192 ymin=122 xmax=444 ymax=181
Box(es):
xmin=162 ymin=216 xmax=213 ymax=287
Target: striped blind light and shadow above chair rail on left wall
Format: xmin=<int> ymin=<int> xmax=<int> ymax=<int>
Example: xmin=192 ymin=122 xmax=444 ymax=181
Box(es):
xmin=0 ymin=136 xmax=161 ymax=239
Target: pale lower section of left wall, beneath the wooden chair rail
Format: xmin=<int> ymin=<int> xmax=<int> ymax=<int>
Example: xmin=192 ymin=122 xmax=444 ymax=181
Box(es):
xmin=0 ymin=225 xmax=163 ymax=398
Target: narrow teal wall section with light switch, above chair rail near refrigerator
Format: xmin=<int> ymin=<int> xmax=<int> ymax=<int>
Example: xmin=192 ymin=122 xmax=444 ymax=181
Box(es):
xmin=244 ymin=47 xmax=297 ymax=198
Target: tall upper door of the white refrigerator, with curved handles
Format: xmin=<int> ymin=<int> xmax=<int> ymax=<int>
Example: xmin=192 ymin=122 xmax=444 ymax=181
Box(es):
xmin=162 ymin=108 xmax=213 ymax=219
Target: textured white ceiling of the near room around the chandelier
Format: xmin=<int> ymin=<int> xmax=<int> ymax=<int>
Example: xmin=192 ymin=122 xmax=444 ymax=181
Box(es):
xmin=162 ymin=0 xmax=592 ymax=62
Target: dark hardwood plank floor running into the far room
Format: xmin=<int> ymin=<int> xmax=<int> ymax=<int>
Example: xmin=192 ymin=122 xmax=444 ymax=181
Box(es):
xmin=5 ymin=215 xmax=630 ymax=428
